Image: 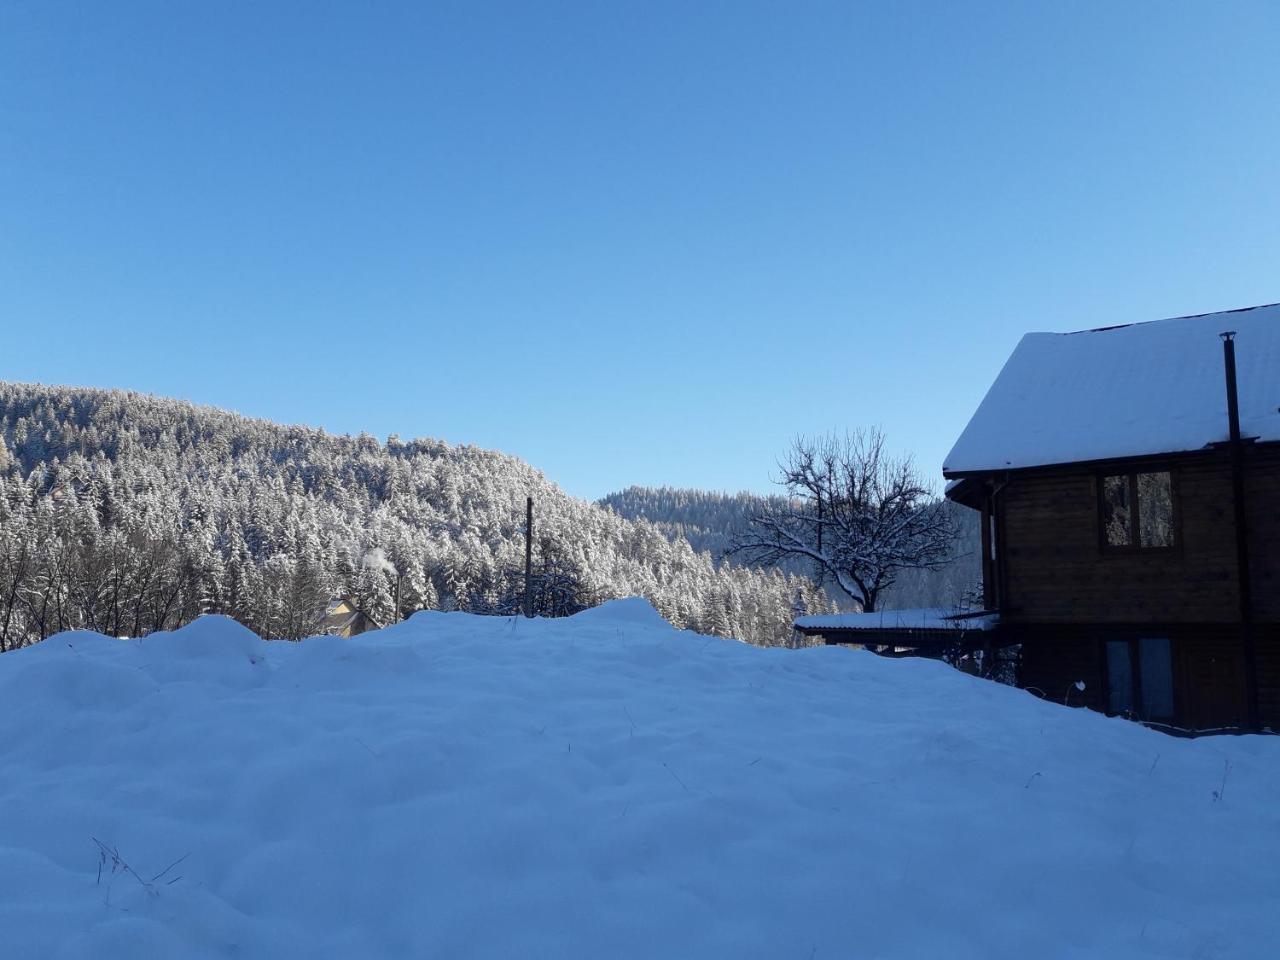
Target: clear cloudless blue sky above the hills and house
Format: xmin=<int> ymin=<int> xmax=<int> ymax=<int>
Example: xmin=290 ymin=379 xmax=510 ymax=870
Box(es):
xmin=0 ymin=1 xmax=1280 ymax=497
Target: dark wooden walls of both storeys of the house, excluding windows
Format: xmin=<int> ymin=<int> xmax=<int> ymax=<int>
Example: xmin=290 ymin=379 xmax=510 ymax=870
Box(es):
xmin=967 ymin=445 xmax=1280 ymax=730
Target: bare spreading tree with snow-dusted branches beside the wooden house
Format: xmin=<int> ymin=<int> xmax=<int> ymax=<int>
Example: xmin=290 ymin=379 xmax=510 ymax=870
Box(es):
xmin=731 ymin=430 xmax=956 ymax=612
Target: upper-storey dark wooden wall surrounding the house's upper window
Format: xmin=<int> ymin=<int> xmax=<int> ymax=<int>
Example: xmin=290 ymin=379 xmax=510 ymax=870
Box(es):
xmin=997 ymin=449 xmax=1280 ymax=623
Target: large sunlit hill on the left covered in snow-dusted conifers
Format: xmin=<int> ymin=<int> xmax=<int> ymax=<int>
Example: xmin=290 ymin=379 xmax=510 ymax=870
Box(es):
xmin=0 ymin=383 xmax=822 ymax=649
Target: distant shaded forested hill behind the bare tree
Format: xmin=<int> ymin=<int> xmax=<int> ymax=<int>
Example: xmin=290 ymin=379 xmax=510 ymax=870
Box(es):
xmin=599 ymin=486 xmax=980 ymax=609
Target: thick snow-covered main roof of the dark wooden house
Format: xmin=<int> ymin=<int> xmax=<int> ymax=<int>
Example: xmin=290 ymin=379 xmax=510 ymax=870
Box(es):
xmin=942 ymin=303 xmax=1280 ymax=476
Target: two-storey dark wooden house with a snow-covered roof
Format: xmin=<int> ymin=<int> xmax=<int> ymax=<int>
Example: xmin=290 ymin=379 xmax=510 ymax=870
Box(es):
xmin=943 ymin=305 xmax=1280 ymax=731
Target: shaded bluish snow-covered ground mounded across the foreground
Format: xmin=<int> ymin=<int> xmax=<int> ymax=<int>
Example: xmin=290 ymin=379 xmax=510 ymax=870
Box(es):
xmin=0 ymin=600 xmax=1280 ymax=960
